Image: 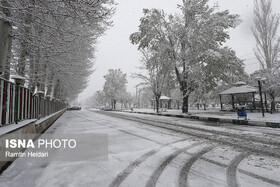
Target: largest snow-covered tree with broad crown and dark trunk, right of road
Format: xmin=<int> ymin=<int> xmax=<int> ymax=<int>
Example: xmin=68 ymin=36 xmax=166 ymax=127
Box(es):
xmin=130 ymin=0 xmax=242 ymax=113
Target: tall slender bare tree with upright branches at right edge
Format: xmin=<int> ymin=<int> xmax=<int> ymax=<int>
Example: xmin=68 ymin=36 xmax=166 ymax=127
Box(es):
xmin=252 ymin=0 xmax=280 ymax=113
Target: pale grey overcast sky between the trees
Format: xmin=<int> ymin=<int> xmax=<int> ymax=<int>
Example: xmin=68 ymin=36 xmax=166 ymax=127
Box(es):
xmin=80 ymin=0 xmax=280 ymax=101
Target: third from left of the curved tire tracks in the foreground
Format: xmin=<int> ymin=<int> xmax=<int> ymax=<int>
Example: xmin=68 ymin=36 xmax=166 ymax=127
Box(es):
xmin=179 ymin=146 xmax=214 ymax=187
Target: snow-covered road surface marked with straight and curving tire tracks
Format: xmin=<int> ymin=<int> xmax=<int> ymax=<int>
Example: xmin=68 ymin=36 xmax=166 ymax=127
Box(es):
xmin=0 ymin=110 xmax=280 ymax=187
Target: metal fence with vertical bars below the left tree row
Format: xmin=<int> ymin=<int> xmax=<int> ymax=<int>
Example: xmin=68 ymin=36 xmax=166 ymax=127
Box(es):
xmin=0 ymin=78 xmax=66 ymax=126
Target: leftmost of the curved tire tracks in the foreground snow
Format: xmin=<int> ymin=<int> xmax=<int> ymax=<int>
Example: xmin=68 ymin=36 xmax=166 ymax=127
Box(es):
xmin=108 ymin=138 xmax=192 ymax=187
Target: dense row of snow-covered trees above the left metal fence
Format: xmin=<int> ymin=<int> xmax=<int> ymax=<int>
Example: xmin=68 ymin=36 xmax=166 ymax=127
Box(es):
xmin=0 ymin=0 xmax=115 ymax=102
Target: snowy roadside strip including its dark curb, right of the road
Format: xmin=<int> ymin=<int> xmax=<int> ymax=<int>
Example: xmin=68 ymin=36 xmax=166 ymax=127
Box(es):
xmin=123 ymin=109 xmax=280 ymax=128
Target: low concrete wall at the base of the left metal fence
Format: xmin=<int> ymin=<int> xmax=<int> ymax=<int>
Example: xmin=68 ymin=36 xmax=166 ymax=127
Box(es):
xmin=0 ymin=110 xmax=65 ymax=173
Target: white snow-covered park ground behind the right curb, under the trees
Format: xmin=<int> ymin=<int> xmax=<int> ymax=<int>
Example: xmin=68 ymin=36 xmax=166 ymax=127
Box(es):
xmin=127 ymin=108 xmax=280 ymax=123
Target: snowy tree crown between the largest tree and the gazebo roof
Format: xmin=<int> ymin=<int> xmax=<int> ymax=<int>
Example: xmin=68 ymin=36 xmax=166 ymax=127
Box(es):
xmin=193 ymin=47 xmax=245 ymax=106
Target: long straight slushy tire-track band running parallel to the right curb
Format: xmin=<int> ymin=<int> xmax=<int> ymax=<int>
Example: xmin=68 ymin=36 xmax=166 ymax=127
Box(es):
xmin=96 ymin=112 xmax=280 ymax=158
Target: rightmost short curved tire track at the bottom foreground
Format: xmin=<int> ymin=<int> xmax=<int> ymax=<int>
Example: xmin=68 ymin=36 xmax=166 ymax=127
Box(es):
xmin=227 ymin=152 xmax=250 ymax=187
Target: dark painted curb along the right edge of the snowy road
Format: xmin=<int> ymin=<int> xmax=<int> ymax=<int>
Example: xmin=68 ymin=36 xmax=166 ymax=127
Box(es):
xmin=118 ymin=111 xmax=280 ymax=128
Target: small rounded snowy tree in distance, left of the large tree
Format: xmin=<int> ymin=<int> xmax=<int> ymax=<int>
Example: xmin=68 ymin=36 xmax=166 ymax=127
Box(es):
xmin=103 ymin=69 xmax=127 ymax=109
